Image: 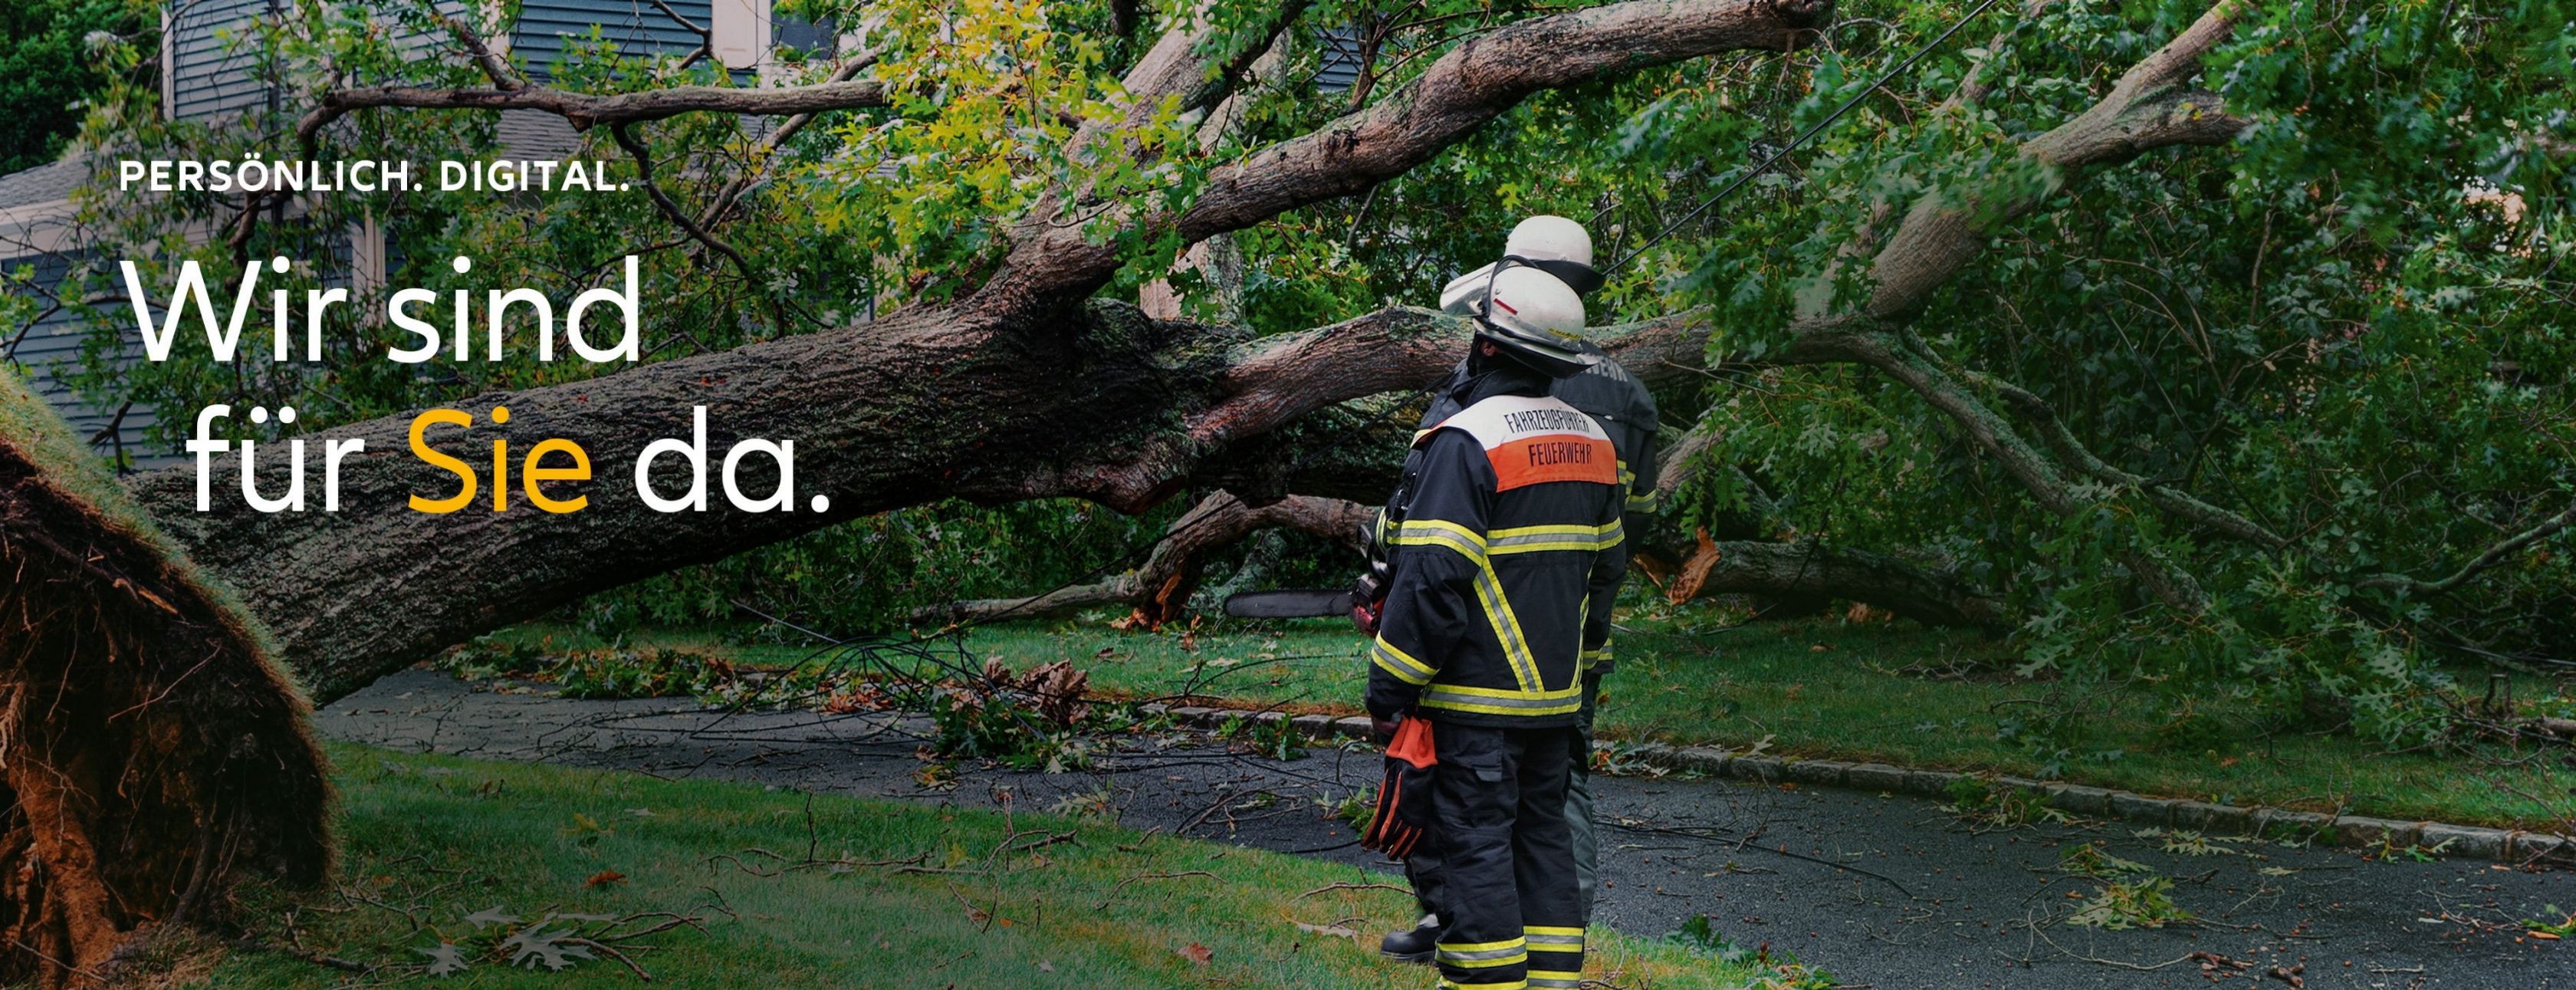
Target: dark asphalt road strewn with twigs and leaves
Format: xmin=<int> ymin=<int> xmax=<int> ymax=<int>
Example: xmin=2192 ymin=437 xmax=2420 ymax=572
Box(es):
xmin=317 ymin=670 xmax=2576 ymax=990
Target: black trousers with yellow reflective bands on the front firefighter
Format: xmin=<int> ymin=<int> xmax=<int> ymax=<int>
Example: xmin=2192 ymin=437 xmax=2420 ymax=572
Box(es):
xmin=1424 ymin=722 xmax=1584 ymax=990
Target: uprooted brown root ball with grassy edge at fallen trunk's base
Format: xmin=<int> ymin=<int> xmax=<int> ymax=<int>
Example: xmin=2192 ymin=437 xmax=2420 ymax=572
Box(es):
xmin=0 ymin=371 xmax=332 ymax=988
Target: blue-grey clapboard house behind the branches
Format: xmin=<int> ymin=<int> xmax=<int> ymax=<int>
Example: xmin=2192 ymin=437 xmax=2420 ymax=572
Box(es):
xmin=0 ymin=0 xmax=843 ymax=469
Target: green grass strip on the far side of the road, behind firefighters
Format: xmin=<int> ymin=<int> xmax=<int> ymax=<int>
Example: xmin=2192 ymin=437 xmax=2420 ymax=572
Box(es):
xmin=468 ymin=613 xmax=2576 ymax=830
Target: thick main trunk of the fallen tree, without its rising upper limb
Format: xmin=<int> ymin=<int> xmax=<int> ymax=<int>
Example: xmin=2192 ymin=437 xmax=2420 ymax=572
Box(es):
xmin=131 ymin=301 xmax=1705 ymax=704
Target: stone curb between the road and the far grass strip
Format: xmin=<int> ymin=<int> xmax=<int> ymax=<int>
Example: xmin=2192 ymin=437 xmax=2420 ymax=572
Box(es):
xmin=1138 ymin=704 xmax=2576 ymax=867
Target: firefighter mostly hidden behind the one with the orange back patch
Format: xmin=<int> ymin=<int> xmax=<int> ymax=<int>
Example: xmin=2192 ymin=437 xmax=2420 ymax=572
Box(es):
xmin=1362 ymin=216 xmax=1659 ymax=962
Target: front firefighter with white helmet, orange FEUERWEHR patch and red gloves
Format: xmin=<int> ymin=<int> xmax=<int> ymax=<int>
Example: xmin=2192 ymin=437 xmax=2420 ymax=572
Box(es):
xmin=1368 ymin=261 xmax=1628 ymax=988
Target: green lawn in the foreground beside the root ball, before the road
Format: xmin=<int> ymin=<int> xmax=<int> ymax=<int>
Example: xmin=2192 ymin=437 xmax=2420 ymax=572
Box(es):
xmin=181 ymin=745 xmax=1777 ymax=988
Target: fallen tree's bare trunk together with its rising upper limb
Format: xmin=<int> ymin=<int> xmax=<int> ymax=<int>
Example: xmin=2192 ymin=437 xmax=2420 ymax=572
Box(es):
xmin=131 ymin=0 xmax=1832 ymax=701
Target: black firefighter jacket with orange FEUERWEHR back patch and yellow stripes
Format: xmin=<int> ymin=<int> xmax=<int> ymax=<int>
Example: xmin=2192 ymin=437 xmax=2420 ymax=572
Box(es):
xmin=1368 ymin=390 xmax=1628 ymax=727
